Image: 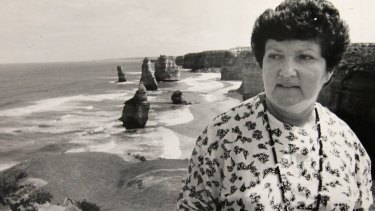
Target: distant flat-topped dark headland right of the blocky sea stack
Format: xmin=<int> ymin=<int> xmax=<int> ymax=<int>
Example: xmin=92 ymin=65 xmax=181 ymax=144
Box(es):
xmin=183 ymin=50 xmax=235 ymax=70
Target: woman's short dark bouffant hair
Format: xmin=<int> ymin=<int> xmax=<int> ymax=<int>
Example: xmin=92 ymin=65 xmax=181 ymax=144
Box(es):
xmin=251 ymin=0 xmax=349 ymax=71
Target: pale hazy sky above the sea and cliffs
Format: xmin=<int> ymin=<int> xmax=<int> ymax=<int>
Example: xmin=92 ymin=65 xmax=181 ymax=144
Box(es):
xmin=0 ymin=0 xmax=375 ymax=63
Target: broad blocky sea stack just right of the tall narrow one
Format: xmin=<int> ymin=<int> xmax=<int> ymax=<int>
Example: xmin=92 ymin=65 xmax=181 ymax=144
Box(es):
xmin=155 ymin=55 xmax=180 ymax=81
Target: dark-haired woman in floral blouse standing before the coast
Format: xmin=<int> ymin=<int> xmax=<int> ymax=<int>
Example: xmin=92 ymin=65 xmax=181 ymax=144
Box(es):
xmin=178 ymin=0 xmax=373 ymax=211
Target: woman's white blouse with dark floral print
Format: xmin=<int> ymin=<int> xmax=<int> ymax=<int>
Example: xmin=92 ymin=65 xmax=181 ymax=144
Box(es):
xmin=177 ymin=93 xmax=373 ymax=211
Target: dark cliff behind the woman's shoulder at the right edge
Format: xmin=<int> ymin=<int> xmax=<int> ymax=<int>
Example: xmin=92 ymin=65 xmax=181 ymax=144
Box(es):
xmin=318 ymin=43 xmax=375 ymax=171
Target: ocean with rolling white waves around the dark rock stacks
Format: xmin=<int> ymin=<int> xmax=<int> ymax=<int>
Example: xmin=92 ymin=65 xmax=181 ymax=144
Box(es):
xmin=0 ymin=58 xmax=241 ymax=170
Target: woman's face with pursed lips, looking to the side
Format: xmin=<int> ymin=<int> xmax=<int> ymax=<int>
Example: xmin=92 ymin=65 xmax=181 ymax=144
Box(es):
xmin=262 ymin=39 xmax=332 ymax=112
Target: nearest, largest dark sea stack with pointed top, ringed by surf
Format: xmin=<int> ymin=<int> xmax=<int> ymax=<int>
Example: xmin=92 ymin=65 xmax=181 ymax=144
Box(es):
xmin=120 ymin=81 xmax=150 ymax=129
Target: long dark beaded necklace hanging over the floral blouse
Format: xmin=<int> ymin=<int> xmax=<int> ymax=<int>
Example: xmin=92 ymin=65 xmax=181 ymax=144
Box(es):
xmin=263 ymin=99 xmax=323 ymax=210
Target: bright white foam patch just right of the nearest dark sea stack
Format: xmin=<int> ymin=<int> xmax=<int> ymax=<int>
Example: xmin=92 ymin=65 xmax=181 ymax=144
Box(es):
xmin=155 ymin=106 xmax=194 ymax=126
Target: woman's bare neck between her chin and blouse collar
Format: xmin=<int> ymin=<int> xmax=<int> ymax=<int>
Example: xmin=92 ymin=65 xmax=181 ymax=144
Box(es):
xmin=266 ymin=99 xmax=315 ymax=127
